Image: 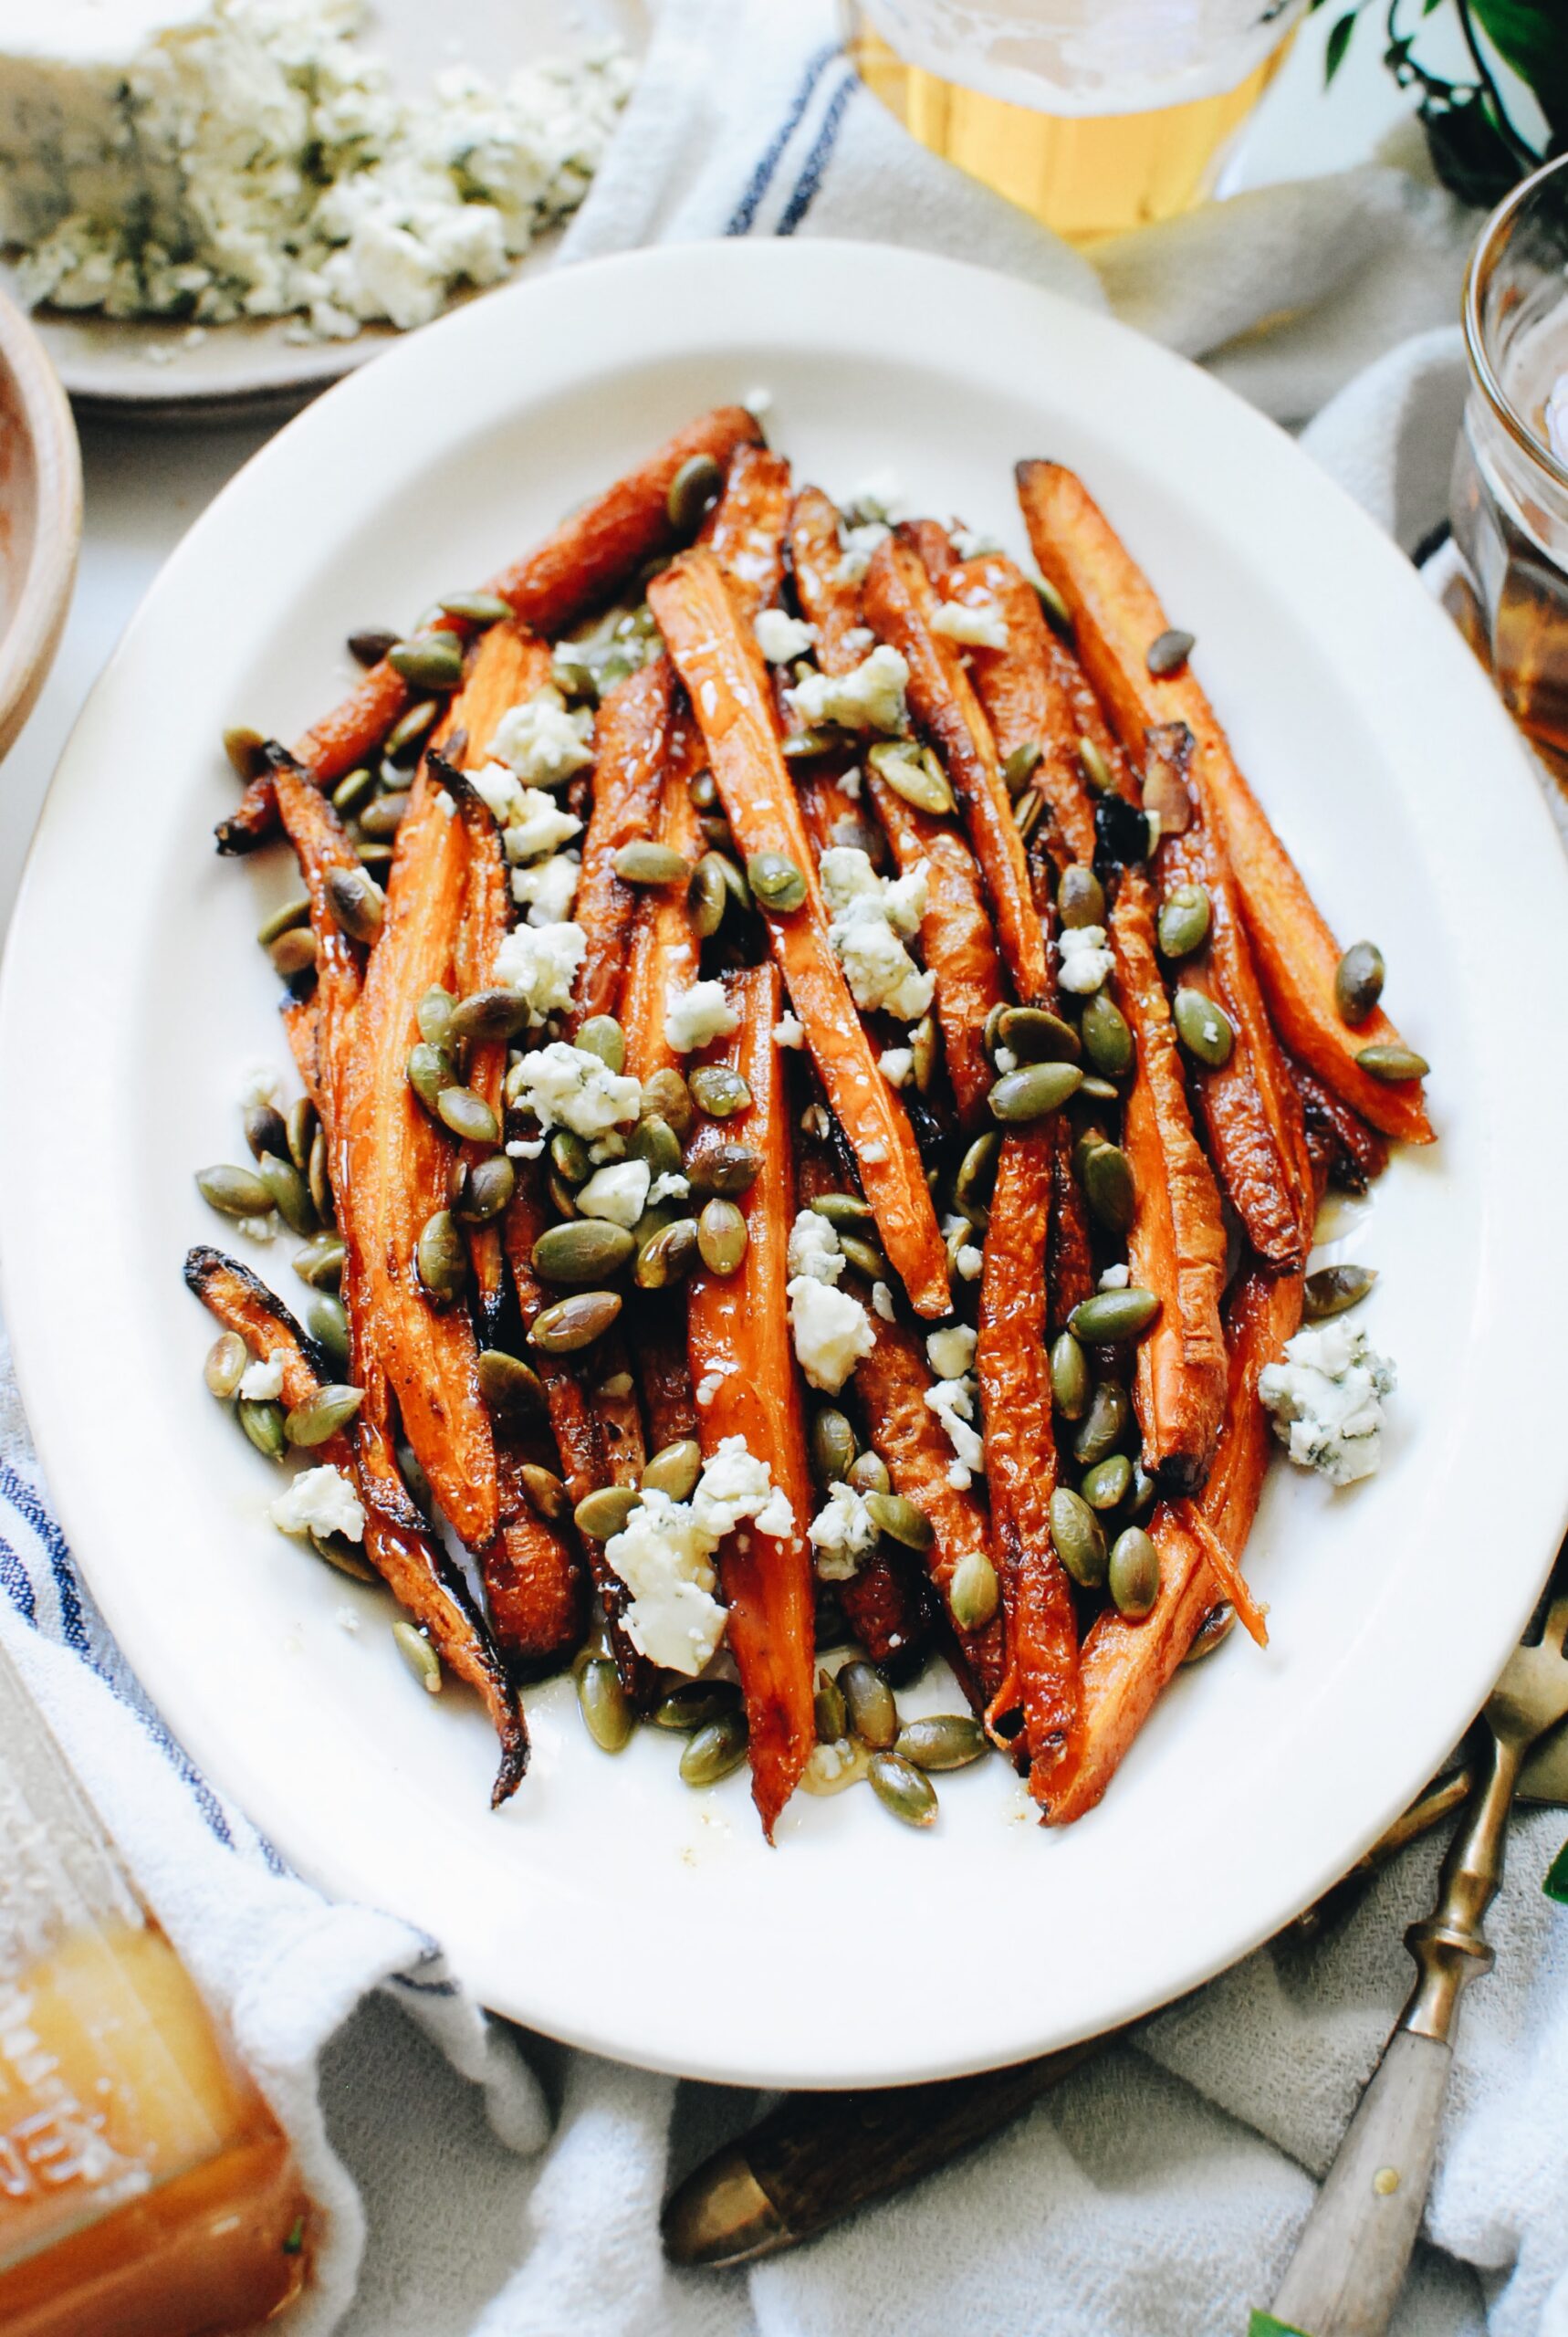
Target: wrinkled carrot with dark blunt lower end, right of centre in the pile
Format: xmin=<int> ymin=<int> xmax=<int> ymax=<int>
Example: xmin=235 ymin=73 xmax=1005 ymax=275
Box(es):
xmin=1110 ymin=867 xmax=1225 ymax=1493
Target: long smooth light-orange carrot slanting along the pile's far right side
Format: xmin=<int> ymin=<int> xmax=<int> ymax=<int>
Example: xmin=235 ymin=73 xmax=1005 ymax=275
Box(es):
xmin=1019 ymin=463 xmax=1432 ymax=1143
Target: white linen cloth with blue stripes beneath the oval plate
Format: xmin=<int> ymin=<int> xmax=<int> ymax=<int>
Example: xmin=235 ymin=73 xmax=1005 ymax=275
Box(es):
xmin=0 ymin=0 xmax=1568 ymax=2337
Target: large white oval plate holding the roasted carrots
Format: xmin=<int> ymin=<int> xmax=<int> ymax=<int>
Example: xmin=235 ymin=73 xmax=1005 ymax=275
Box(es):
xmin=0 ymin=241 xmax=1568 ymax=2085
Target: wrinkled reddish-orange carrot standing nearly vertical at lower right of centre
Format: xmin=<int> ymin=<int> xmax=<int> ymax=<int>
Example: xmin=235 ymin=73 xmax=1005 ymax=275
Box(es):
xmin=975 ymin=1127 xmax=1080 ymax=1802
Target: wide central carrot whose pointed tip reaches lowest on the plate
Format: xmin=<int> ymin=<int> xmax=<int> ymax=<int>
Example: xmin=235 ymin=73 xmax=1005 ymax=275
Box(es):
xmin=687 ymin=965 xmax=816 ymax=1841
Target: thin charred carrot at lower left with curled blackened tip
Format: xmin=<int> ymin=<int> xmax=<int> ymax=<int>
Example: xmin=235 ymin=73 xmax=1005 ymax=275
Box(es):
xmin=184 ymin=1248 xmax=528 ymax=1807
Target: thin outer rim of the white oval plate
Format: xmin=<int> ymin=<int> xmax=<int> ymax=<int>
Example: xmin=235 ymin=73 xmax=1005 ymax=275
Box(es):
xmin=0 ymin=241 xmax=1568 ymax=2087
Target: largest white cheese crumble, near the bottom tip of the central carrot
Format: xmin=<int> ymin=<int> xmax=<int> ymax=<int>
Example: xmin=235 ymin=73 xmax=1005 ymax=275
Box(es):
xmin=605 ymin=1437 xmax=795 ymax=1676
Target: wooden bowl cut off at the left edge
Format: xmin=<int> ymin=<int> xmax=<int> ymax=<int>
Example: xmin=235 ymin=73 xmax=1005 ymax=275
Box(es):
xmin=0 ymin=281 xmax=82 ymax=755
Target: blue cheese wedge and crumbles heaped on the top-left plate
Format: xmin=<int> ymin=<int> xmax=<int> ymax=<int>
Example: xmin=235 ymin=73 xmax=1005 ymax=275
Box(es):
xmin=0 ymin=0 xmax=631 ymax=339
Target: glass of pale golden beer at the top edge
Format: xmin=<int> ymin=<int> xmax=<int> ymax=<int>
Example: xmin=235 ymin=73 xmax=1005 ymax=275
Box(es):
xmin=846 ymin=0 xmax=1306 ymax=243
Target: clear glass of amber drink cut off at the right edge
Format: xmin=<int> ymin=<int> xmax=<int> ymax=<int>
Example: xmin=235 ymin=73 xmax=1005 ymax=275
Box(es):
xmin=1451 ymin=157 xmax=1568 ymax=781
